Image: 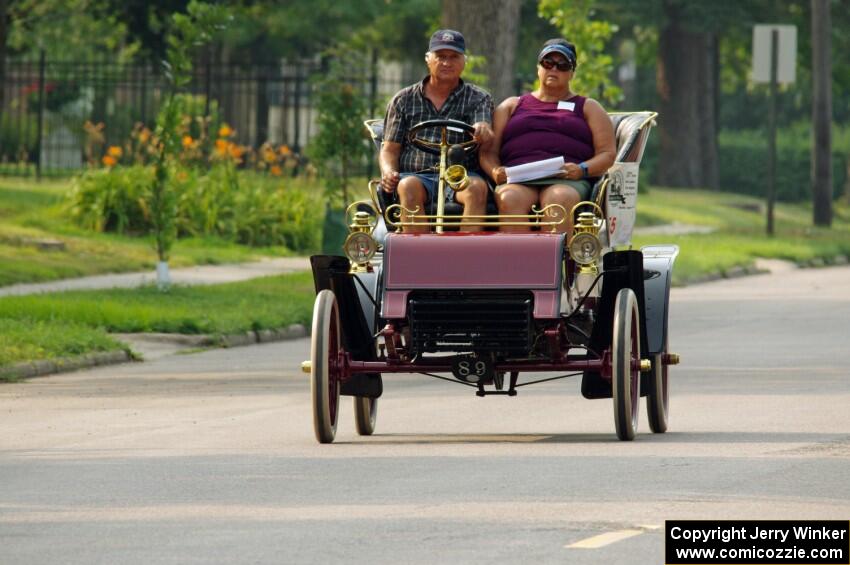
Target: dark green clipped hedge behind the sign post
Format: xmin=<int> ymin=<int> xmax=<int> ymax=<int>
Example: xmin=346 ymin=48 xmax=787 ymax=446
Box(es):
xmin=719 ymin=128 xmax=850 ymax=202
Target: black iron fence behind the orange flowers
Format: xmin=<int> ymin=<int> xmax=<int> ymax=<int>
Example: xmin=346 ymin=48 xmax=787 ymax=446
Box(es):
xmin=0 ymin=56 xmax=412 ymax=175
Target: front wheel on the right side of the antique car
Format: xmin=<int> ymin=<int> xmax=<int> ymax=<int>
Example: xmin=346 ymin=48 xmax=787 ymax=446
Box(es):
xmin=611 ymin=288 xmax=640 ymax=441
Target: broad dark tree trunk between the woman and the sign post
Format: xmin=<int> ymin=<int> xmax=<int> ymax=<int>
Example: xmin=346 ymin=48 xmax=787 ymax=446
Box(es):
xmin=656 ymin=2 xmax=719 ymax=188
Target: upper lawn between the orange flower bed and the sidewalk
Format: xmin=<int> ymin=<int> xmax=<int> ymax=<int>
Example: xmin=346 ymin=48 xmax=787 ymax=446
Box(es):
xmin=0 ymin=179 xmax=291 ymax=286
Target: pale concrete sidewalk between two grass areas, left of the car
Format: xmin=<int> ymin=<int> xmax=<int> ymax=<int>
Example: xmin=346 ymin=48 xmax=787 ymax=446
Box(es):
xmin=0 ymin=257 xmax=310 ymax=296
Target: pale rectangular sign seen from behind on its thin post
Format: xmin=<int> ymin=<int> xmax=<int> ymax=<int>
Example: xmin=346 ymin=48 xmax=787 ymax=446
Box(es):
xmin=753 ymin=24 xmax=797 ymax=235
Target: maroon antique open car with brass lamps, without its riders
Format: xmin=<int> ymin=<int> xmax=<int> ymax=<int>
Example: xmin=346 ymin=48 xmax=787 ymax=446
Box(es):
xmin=302 ymin=112 xmax=679 ymax=443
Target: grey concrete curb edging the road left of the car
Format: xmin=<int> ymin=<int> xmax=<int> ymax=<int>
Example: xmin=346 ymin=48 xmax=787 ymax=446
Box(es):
xmin=0 ymin=324 xmax=309 ymax=382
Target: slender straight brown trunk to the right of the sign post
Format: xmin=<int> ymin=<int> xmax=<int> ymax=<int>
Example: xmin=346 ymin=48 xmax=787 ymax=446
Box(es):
xmin=812 ymin=0 xmax=832 ymax=226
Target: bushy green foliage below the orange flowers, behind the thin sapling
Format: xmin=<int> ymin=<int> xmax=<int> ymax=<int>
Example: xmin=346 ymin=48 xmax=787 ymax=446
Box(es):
xmin=70 ymin=162 xmax=324 ymax=252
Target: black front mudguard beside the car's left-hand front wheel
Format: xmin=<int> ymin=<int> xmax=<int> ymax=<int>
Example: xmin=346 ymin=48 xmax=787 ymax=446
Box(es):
xmin=310 ymin=255 xmax=384 ymax=398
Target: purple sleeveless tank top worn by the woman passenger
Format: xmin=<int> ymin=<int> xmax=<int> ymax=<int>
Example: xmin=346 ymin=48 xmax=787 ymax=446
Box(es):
xmin=499 ymin=94 xmax=594 ymax=167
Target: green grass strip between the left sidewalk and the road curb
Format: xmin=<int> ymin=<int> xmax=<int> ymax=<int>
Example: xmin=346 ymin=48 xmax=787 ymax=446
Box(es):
xmin=0 ymin=272 xmax=314 ymax=366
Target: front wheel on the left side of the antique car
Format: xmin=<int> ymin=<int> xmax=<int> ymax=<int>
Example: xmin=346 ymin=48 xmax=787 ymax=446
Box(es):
xmin=310 ymin=290 xmax=342 ymax=443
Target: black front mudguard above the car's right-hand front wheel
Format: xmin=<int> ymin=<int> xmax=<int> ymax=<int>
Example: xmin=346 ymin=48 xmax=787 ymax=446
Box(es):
xmin=581 ymin=250 xmax=647 ymax=398
